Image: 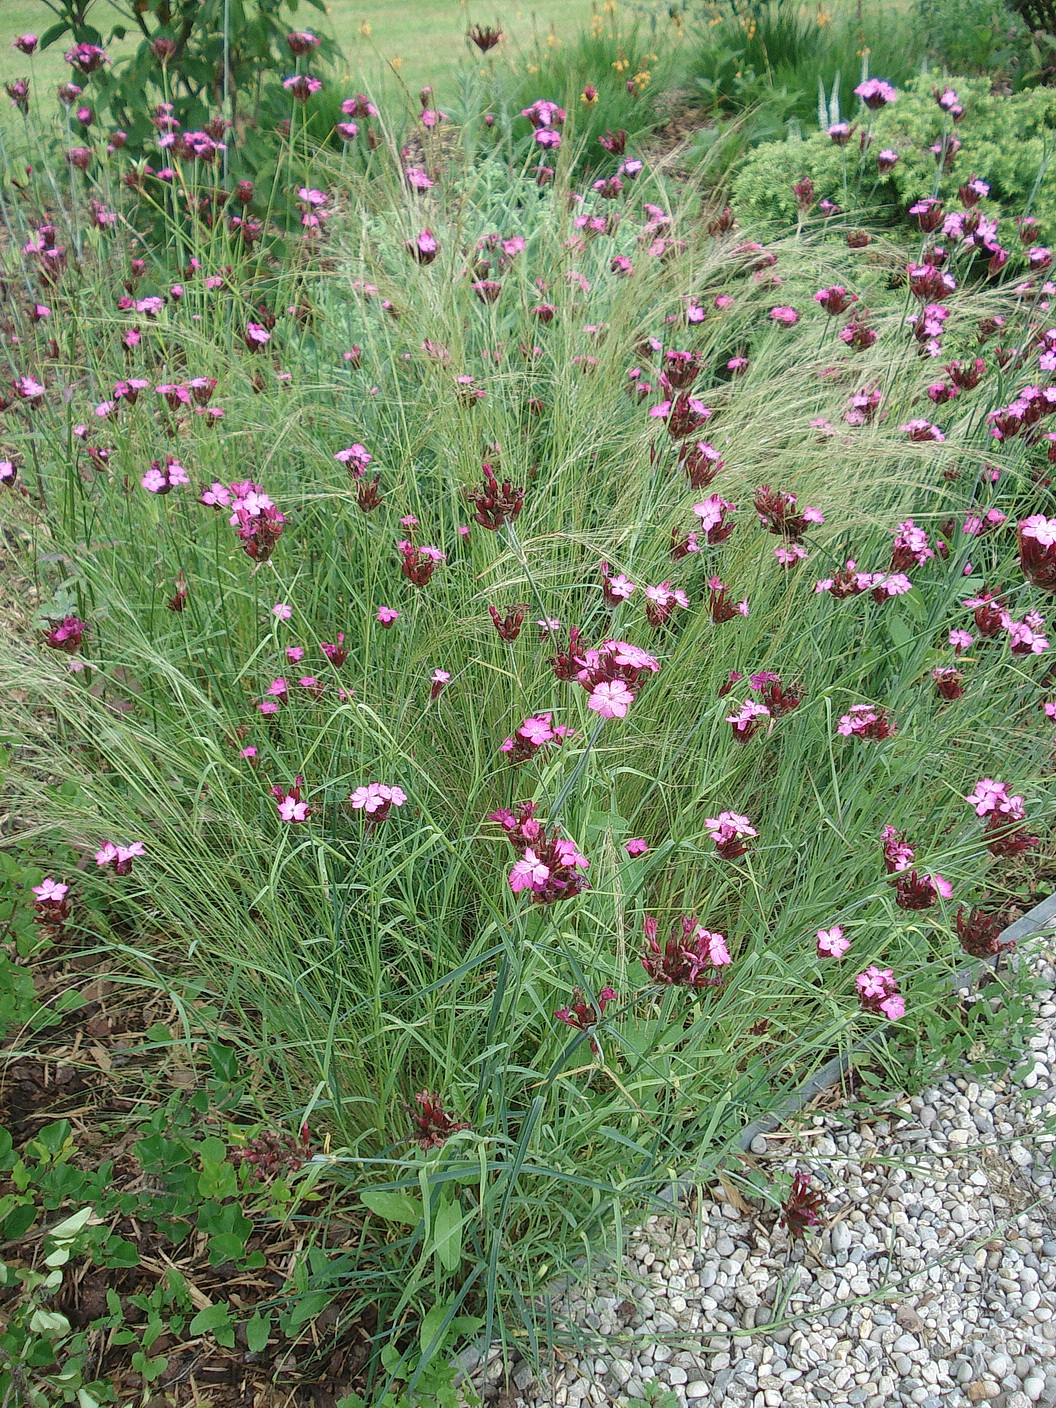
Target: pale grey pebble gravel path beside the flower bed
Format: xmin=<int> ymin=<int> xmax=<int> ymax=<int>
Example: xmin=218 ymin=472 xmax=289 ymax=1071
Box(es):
xmin=477 ymin=941 xmax=1056 ymax=1408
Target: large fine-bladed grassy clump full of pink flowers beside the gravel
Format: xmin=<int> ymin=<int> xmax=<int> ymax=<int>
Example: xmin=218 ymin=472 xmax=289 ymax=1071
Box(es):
xmin=0 ymin=27 xmax=1052 ymax=1402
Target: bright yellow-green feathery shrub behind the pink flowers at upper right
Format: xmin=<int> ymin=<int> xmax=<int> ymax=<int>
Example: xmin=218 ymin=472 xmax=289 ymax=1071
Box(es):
xmin=732 ymin=75 xmax=1056 ymax=222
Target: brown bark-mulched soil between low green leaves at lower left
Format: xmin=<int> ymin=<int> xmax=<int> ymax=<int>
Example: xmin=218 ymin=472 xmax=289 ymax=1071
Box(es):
xmin=0 ymin=950 xmax=376 ymax=1408
